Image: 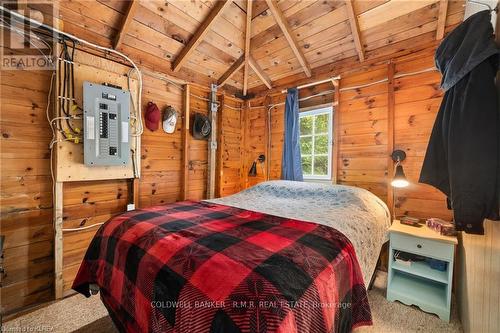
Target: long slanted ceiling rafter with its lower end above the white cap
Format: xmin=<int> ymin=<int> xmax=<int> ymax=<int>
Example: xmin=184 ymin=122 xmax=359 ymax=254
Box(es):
xmin=172 ymin=0 xmax=233 ymax=72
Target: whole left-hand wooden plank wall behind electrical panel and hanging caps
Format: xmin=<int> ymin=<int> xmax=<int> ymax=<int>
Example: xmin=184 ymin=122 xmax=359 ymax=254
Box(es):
xmin=0 ymin=47 xmax=242 ymax=314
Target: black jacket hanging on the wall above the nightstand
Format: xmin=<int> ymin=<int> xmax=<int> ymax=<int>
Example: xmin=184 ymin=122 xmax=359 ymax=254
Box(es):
xmin=419 ymin=11 xmax=500 ymax=234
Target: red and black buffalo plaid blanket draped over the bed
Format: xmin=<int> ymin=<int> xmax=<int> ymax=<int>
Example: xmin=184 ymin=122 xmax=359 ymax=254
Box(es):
xmin=73 ymin=202 xmax=371 ymax=333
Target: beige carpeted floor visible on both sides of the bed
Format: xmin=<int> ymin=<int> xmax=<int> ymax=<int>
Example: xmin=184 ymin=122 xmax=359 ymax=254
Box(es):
xmin=2 ymin=272 xmax=462 ymax=333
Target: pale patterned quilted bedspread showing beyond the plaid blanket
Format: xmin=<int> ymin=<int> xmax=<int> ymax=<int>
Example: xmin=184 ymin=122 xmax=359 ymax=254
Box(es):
xmin=207 ymin=180 xmax=391 ymax=286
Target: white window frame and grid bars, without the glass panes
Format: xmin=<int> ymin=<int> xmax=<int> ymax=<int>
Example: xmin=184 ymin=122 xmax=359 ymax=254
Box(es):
xmin=299 ymin=106 xmax=334 ymax=180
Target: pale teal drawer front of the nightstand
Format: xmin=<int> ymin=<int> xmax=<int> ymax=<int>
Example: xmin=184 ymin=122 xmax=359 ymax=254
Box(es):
xmin=391 ymin=232 xmax=455 ymax=261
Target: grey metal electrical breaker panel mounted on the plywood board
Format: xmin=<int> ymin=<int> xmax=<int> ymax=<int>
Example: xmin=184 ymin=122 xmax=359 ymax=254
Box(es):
xmin=83 ymin=82 xmax=130 ymax=166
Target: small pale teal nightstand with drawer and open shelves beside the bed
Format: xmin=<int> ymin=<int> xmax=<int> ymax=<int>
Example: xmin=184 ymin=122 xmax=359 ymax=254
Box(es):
xmin=387 ymin=220 xmax=458 ymax=321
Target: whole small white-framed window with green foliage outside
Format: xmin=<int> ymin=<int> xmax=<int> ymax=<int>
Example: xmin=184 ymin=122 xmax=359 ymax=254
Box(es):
xmin=299 ymin=107 xmax=332 ymax=179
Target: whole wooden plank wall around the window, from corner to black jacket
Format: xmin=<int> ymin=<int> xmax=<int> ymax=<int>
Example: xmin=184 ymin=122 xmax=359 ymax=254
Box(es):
xmin=245 ymin=44 xmax=451 ymax=219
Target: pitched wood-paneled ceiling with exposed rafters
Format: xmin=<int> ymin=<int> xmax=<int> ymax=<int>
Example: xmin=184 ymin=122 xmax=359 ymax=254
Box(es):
xmin=46 ymin=0 xmax=464 ymax=90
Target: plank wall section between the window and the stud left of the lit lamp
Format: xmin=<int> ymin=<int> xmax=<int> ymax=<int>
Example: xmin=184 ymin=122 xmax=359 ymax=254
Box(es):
xmin=337 ymin=64 xmax=388 ymax=202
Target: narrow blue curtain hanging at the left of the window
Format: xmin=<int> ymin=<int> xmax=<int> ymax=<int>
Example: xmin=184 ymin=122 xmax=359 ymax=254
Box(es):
xmin=281 ymin=88 xmax=304 ymax=181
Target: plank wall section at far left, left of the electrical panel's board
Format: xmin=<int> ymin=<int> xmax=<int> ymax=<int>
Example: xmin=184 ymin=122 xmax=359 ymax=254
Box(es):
xmin=0 ymin=67 xmax=54 ymax=313
